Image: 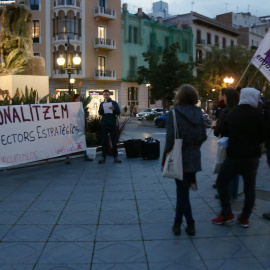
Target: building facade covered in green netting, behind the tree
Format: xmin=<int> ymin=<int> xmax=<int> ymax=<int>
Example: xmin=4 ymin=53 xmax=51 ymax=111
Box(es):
xmin=121 ymin=4 xmax=193 ymax=110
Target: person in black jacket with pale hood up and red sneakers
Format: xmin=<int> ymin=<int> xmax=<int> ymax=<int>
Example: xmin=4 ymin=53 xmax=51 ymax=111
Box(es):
xmin=212 ymin=88 xmax=264 ymax=228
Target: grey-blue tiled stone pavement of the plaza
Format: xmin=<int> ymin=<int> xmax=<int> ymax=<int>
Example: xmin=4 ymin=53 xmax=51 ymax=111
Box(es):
xmin=0 ymin=132 xmax=270 ymax=270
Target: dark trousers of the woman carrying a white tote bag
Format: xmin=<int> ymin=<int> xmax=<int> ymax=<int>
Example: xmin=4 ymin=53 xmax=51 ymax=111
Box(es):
xmin=175 ymin=172 xmax=196 ymax=224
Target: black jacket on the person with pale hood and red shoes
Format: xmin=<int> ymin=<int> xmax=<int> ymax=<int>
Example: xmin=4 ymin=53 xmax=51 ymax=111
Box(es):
xmin=226 ymin=104 xmax=264 ymax=158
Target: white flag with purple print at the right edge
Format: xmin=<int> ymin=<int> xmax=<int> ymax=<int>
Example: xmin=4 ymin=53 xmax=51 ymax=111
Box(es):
xmin=251 ymin=30 xmax=270 ymax=81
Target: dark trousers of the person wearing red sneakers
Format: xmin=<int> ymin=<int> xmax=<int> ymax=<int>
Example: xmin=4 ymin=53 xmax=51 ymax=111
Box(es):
xmin=217 ymin=157 xmax=259 ymax=219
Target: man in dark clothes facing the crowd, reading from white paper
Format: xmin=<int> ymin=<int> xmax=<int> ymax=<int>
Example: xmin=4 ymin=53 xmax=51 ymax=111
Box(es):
xmin=98 ymin=89 xmax=121 ymax=164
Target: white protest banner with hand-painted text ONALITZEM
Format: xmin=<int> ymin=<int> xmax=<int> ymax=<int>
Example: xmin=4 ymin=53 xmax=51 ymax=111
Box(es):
xmin=0 ymin=102 xmax=86 ymax=167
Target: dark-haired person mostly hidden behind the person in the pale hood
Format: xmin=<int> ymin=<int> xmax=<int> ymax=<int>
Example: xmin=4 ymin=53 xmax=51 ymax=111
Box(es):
xmin=214 ymin=88 xmax=239 ymax=199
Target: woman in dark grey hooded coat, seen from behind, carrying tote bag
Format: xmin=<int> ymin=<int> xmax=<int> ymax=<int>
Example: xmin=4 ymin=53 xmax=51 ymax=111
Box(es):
xmin=162 ymin=84 xmax=207 ymax=235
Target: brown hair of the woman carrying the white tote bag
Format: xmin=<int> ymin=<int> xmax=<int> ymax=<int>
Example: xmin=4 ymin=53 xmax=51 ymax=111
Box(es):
xmin=174 ymin=84 xmax=198 ymax=106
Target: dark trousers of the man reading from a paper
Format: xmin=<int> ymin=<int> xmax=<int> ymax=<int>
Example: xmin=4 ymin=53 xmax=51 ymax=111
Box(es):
xmin=101 ymin=125 xmax=118 ymax=158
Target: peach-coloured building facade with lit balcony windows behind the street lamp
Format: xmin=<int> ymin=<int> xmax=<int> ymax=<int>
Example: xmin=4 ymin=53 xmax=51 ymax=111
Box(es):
xmin=27 ymin=0 xmax=121 ymax=115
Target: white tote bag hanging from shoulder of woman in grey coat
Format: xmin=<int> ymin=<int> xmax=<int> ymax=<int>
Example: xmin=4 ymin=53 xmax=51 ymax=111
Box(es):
xmin=163 ymin=109 xmax=183 ymax=180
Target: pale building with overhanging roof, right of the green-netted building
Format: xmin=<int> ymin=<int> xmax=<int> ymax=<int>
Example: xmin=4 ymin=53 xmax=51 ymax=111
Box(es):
xmin=164 ymin=12 xmax=239 ymax=64
